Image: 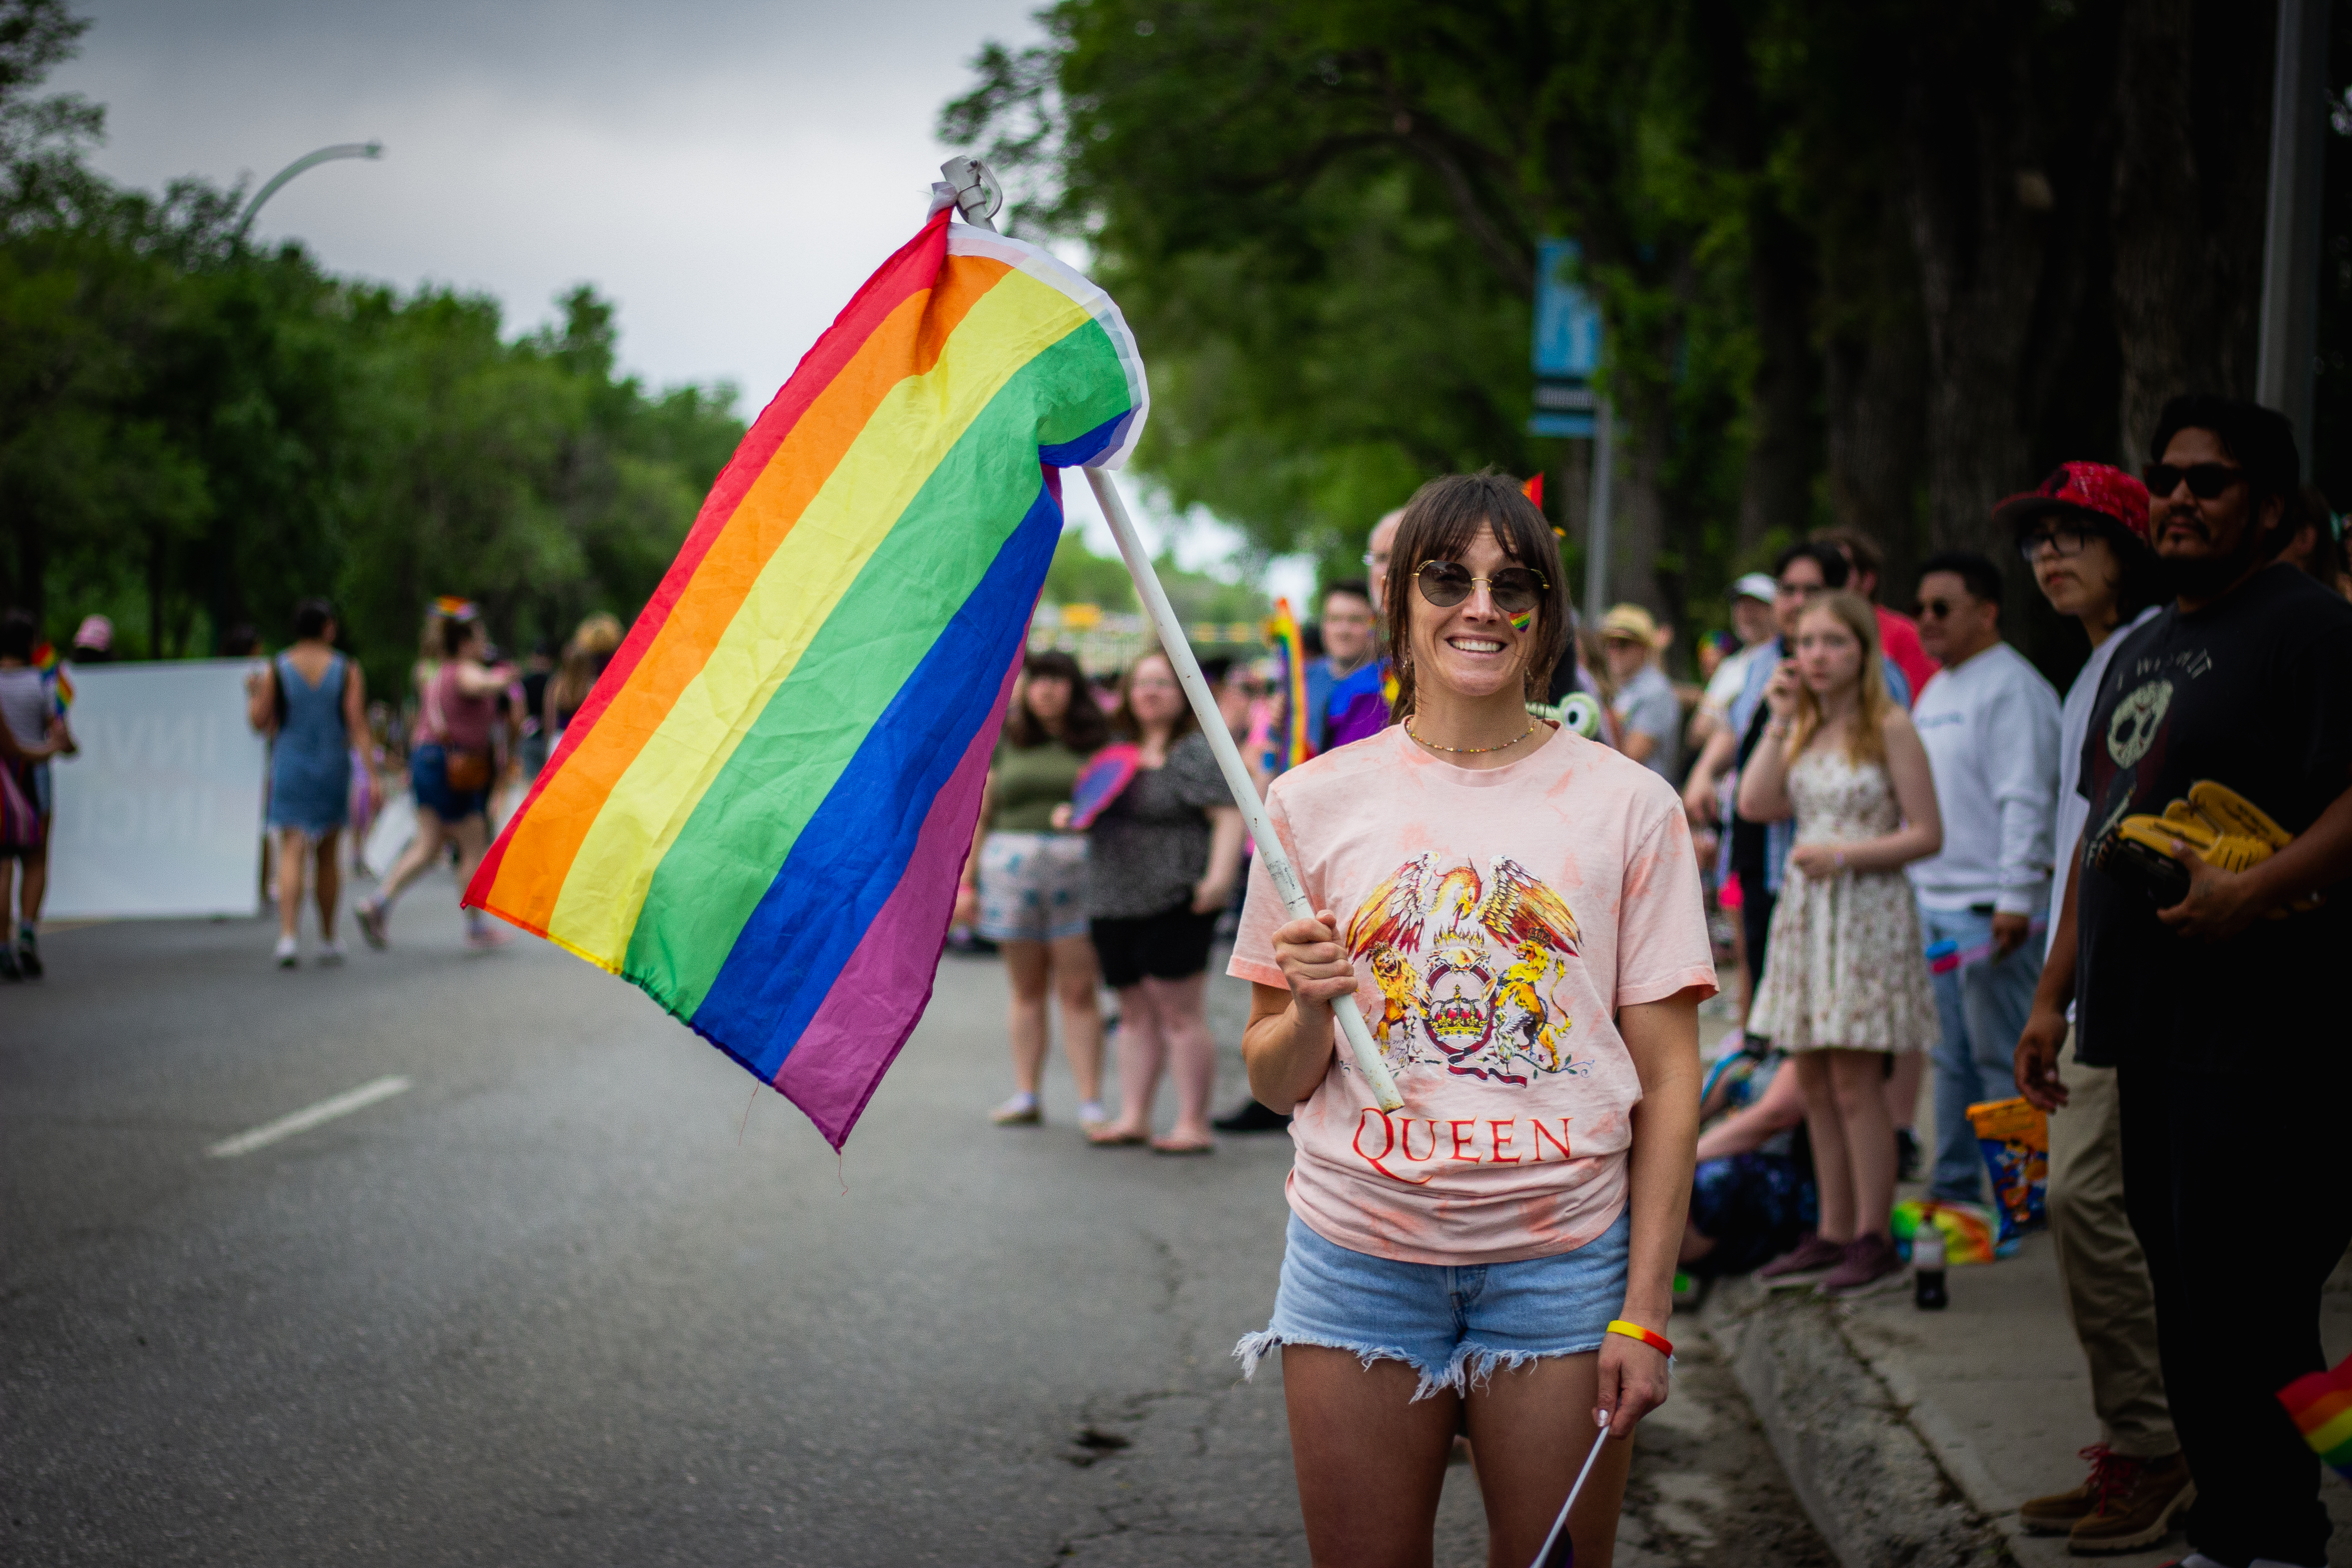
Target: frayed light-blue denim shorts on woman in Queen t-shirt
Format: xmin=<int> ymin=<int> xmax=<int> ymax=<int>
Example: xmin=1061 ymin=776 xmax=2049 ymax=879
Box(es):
xmin=1232 ymin=1208 xmax=1632 ymax=1399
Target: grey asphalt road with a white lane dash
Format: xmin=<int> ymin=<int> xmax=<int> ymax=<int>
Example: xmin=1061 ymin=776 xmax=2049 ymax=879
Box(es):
xmin=0 ymin=882 xmax=1828 ymax=1568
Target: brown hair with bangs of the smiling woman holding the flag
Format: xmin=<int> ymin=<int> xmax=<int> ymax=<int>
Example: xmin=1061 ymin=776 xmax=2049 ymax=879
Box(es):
xmin=1383 ymin=468 xmax=1569 ymax=724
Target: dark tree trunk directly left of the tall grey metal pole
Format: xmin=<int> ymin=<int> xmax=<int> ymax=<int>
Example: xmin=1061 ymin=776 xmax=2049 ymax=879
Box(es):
xmin=2110 ymin=0 xmax=2277 ymax=468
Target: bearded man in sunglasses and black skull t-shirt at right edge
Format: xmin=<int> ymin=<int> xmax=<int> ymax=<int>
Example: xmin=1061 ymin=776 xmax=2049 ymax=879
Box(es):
xmin=2018 ymin=397 xmax=2352 ymax=1568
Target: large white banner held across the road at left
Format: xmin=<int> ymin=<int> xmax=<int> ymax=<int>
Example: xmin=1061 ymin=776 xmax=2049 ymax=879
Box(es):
xmin=42 ymin=658 xmax=266 ymax=919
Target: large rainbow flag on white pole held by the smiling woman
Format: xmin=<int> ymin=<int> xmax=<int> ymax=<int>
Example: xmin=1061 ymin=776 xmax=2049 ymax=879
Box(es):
xmin=466 ymin=207 xmax=1148 ymax=1150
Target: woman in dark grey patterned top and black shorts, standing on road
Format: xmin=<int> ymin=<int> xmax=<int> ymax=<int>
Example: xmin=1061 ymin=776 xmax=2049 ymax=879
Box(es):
xmin=1087 ymin=651 xmax=1242 ymax=1154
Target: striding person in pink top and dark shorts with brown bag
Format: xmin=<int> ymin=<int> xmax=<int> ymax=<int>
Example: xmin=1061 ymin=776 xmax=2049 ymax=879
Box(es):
xmin=353 ymin=604 xmax=515 ymax=947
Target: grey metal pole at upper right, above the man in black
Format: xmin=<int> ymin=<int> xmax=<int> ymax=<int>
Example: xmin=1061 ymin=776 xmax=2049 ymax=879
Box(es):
xmin=2253 ymin=0 xmax=2328 ymax=475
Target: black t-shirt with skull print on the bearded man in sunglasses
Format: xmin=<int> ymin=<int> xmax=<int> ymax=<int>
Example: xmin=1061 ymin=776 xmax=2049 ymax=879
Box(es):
xmin=2060 ymin=567 xmax=2352 ymax=1067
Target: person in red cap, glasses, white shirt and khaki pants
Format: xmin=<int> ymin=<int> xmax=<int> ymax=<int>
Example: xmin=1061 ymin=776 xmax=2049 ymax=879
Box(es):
xmin=1992 ymin=463 xmax=2192 ymax=1552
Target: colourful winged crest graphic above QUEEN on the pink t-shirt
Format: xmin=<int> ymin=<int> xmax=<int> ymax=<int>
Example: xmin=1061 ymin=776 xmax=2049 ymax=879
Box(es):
xmin=1345 ymin=851 xmax=1585 ymax=1086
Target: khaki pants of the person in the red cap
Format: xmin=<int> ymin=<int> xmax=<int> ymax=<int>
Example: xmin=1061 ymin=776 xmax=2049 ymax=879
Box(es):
xmin=2048 ymin=1029 xmax=2180 ymax=1460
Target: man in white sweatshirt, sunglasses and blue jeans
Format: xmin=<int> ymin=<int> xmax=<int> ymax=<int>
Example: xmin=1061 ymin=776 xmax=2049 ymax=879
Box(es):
xmin=1910 ymin=550 xmax=2058 ymax=1204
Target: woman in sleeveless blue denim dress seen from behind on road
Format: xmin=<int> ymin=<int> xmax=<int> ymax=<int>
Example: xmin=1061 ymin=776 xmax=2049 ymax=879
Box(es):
xmin=245 ymin=599 xmax=374 ymax=969
